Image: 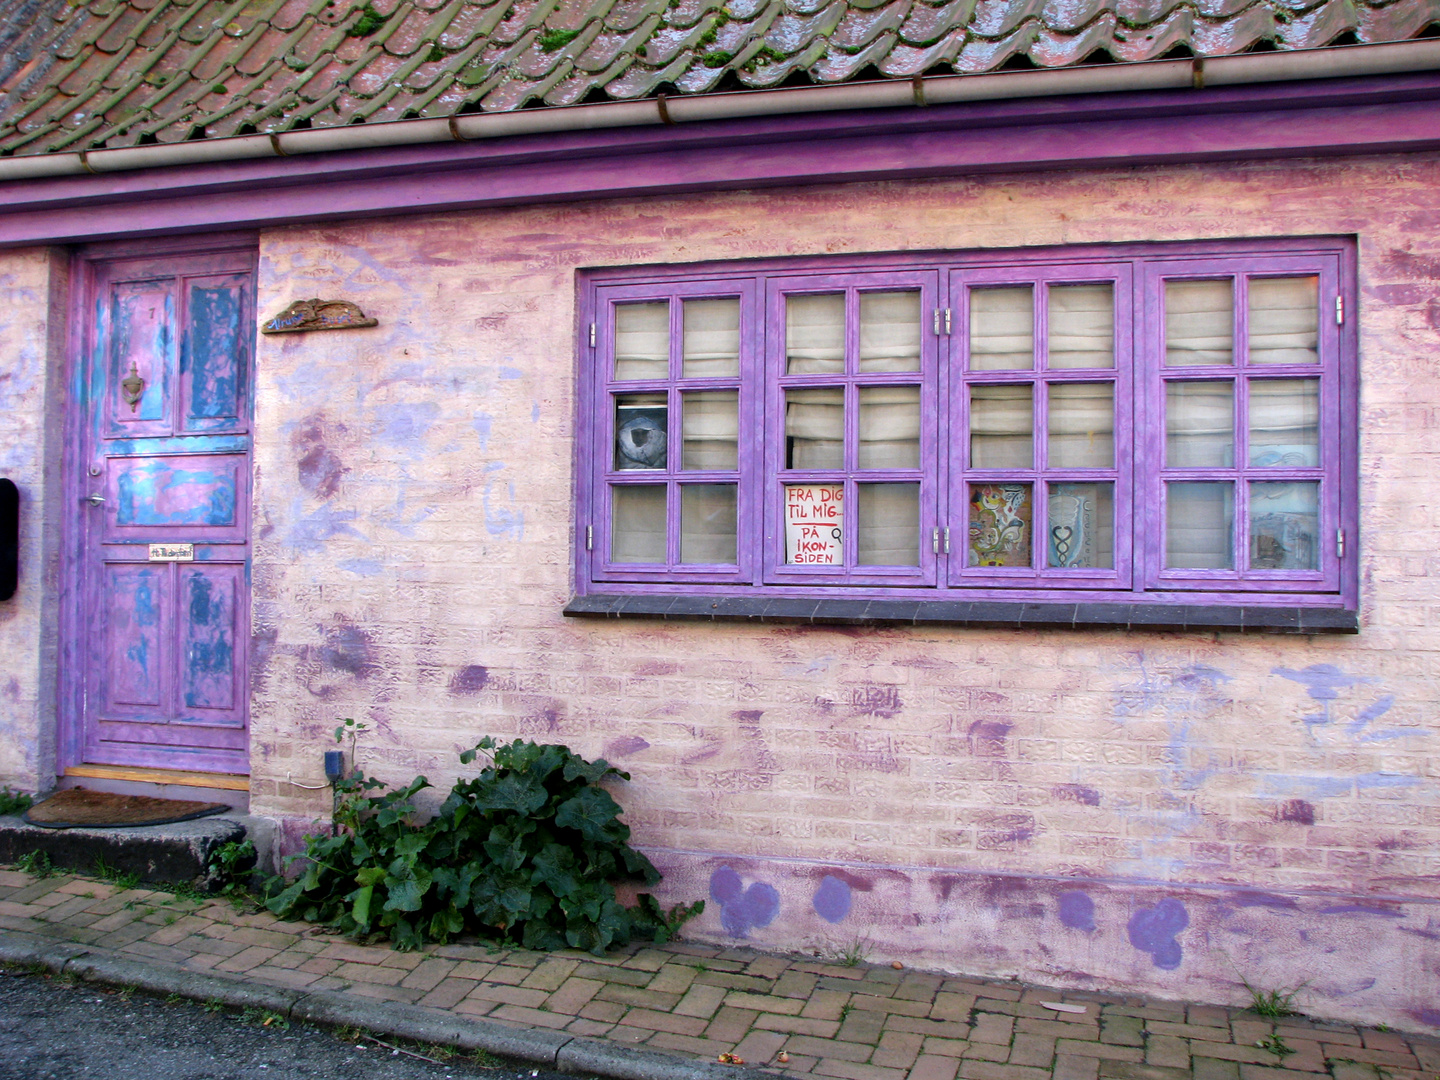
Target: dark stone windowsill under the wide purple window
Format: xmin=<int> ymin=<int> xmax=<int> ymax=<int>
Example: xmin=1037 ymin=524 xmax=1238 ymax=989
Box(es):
xmin=563 ymin=593 xmax=1359 ymax=634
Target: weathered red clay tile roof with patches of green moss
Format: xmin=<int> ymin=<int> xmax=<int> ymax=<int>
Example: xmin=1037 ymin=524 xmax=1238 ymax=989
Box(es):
xmin=0 ymin=0 xmax=1440 ymax=169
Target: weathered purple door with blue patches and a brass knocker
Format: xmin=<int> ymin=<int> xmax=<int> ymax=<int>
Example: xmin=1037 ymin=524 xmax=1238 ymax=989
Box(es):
xmin=66 ymin=251 xmax=255 ymax=773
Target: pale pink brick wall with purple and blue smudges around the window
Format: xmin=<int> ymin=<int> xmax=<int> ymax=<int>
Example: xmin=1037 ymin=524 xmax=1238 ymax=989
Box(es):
xmin=0 ymin=156 xmax=1440 ymax=1027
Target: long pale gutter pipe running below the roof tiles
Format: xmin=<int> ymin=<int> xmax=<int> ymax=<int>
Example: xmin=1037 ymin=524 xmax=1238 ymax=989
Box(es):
xmin=8 ymin=39 xmax=1440 ymax=181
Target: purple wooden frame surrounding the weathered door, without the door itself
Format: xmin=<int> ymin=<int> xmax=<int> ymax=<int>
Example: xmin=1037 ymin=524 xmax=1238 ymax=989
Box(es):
xmin=55 ymin=230 xmax=259 ymax=776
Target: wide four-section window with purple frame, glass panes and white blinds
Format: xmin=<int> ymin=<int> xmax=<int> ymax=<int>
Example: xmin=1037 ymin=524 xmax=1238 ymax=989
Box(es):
xmin=579 ymin=242 xmax=1355 ymax=616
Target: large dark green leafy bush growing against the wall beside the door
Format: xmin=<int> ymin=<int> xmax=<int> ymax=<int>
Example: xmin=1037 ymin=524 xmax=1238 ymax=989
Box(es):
xmin=266 ymin=737 xmax=704 ymax=953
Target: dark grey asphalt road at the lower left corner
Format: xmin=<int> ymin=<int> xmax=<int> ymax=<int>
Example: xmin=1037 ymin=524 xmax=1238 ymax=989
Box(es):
xmin=0 ymin=968 xmax=575 ymax=1080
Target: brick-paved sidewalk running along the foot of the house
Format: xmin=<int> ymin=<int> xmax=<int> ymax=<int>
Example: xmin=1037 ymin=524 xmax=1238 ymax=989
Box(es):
xmin=0 ymin=870 xmax=1440 ymax=1080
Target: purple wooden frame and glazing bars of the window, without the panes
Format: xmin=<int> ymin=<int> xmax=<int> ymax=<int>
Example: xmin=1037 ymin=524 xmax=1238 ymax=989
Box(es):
xmin=576 ymin=238 xmax=1359 ymax=611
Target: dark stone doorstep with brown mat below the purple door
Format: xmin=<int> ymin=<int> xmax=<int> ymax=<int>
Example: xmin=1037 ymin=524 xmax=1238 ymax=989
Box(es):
xmin=0 ymin=815 xmax=251 ymax=891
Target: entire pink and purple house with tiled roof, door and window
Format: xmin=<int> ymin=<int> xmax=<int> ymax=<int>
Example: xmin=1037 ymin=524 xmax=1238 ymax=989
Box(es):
xmin=0 ymin=0 xmax=1440 ymax=1031
